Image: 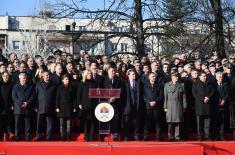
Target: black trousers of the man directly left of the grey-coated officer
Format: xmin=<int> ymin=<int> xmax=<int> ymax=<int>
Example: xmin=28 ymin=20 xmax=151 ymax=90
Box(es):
xmin=144 ymin=109 xmax=162 ymax=140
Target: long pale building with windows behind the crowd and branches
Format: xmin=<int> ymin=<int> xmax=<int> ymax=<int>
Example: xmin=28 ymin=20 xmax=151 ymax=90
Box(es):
xmin=0 ymin=16 xmax=161 ymax=56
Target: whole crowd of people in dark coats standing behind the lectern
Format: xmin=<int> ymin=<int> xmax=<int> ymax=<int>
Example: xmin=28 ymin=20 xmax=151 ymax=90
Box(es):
xmin=0 ymin=50 xmax=235 ymax=141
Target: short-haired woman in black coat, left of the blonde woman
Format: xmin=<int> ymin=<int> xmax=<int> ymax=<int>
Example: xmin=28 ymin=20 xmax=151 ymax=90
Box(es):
xmin=56 ymin=74 xmax=76 ymax=140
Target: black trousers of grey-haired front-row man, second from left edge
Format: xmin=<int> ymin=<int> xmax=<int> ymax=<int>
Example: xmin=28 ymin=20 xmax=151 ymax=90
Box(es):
xmin=15 ymin=115 xmax=30 ymax=140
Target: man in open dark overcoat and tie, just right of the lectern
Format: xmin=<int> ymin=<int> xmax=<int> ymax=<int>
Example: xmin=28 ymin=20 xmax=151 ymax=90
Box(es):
xmin=123 ymin=69 xmax=143 ymax=141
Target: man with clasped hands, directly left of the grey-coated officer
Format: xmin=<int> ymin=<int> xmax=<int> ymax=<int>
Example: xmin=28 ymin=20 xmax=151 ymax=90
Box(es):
xmin=144 ymin=72 xmax=164 ymax=141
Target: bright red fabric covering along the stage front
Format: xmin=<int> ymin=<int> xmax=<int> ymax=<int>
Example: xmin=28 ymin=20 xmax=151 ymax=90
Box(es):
xmin=0 ymin=141 xmax=235 ymax=155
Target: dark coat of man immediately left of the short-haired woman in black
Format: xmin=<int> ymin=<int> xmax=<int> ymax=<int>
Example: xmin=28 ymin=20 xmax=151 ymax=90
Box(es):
xmin=36 ymin=81 xmax=57 ymax=114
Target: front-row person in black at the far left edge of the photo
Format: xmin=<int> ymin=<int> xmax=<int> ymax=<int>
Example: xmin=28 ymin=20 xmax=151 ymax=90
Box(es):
xmin=0 ymin=72 xmax=14 ymax=141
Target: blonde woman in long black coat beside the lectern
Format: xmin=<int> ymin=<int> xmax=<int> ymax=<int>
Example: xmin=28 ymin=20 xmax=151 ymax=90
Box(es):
xmin=77 ymin=70 xmax=98 ymax=141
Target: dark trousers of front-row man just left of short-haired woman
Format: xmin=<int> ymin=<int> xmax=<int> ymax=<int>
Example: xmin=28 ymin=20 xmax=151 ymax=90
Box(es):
xmin=36 ymin=114 xmax=53 ymax=140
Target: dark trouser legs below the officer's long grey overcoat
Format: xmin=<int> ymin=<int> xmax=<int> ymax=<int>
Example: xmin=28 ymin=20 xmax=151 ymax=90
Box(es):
xmin=168 ymin=123 xmax=182 ymax=140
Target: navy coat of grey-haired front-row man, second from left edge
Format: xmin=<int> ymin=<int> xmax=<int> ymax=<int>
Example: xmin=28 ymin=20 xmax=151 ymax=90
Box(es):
xmin=12 ymin=84 xmax=35 ymax=115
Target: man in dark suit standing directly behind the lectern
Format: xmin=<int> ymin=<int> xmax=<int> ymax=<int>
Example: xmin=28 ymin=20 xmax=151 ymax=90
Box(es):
xmin=104 ymin=67 xmax=123 ymax=141
